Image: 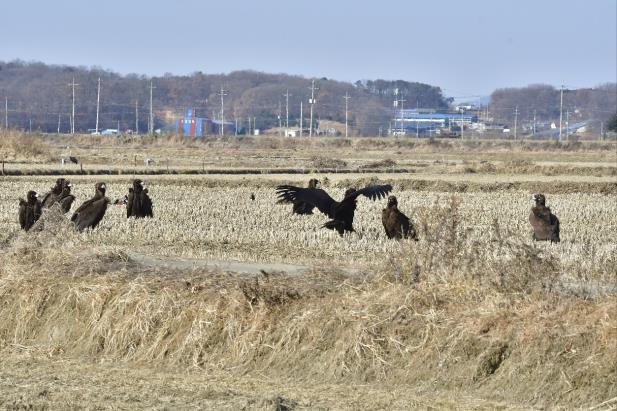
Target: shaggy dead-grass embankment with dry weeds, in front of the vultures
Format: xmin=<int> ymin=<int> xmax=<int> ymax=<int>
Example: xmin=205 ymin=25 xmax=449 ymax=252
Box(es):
xmin=0 ymin=209 xmax=617 ymax=408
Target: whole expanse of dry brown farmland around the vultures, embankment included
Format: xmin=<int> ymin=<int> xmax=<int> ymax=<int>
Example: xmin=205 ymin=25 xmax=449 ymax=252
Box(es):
xmin=0 ymin=133 xmax=617 ymax=410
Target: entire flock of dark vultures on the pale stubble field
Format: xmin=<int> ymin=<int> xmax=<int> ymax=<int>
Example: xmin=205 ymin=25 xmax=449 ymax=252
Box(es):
xmin=19 ymin=178 xmax=560 ymax=242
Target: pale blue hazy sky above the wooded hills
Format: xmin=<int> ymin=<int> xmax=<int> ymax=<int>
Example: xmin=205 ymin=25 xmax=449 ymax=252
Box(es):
xmin=0 ymin=0 xmax=617 ymax=99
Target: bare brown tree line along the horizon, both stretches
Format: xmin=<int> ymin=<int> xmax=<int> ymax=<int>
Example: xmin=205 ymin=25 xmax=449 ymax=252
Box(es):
xmin=0 ymin=60 xmax=617 ymax=136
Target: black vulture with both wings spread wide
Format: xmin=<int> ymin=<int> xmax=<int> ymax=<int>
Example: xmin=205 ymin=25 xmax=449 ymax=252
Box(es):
xmin=276 ymin=184 xmax=392 ymax=236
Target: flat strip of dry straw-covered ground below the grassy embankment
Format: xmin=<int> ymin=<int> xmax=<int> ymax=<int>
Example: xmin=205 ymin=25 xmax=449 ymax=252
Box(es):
xmin=0 ymin=354 xmax=523 ymax=411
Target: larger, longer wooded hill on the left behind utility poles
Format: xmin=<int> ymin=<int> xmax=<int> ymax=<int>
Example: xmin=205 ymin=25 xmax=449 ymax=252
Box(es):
xmin=0 ymin=61 xmax=450 ymax=135
